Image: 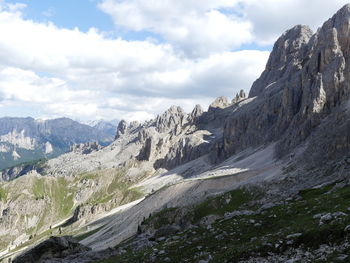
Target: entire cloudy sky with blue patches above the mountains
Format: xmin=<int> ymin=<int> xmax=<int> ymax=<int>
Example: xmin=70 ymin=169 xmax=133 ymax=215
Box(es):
xmin=0 ymin=0 xmax=347 ymax=121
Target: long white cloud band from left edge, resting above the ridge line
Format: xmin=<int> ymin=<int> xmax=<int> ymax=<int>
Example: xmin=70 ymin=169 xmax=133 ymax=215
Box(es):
xmin=0 ymin=3 xmax=268 ymax=120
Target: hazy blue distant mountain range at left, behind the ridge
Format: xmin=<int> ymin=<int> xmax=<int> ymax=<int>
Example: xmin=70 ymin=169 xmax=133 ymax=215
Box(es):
xmin=0 ymin=117 xmax=116 ymax=169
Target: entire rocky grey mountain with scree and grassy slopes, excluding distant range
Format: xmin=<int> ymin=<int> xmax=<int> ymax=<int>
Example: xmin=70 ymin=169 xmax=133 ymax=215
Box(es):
xmin=0 ymin=5 xmax=350 ymax=263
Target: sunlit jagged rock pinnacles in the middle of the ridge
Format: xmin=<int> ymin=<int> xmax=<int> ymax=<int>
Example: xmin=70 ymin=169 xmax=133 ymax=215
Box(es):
xmin=137 ymin=105 xmax=216 ymax=169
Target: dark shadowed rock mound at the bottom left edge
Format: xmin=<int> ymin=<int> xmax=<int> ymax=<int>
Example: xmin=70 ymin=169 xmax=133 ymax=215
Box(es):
xmin=13 ymin=236 xmax=91 ymax=263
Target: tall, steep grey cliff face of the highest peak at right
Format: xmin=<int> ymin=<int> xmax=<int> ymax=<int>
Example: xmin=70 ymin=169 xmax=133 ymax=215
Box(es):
xmin=218 ymin=5 xmax=350 ymax=161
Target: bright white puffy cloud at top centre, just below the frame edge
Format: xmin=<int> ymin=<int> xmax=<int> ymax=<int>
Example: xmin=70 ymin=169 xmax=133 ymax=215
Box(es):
xmin=100 ymin=0 xmax=253 ymax=57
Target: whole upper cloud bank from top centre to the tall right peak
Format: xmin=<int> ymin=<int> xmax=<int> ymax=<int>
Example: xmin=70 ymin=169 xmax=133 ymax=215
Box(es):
xmin=100 ymin=0 xmax=348 ymax=48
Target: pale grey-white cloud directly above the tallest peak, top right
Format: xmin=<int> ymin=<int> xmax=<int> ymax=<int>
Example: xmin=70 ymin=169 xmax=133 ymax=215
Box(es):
xmin=241 ymin=0 xmax=349 ymax=44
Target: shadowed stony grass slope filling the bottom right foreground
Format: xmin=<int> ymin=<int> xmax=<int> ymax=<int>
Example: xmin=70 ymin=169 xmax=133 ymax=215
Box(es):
xmin=95 ymin=176 xmax=350 ymax=263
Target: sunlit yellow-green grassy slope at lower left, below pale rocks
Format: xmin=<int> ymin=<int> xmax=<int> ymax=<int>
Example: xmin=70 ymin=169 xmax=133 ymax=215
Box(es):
xmin=0 ymin=167 xmax=143 ymax=254
